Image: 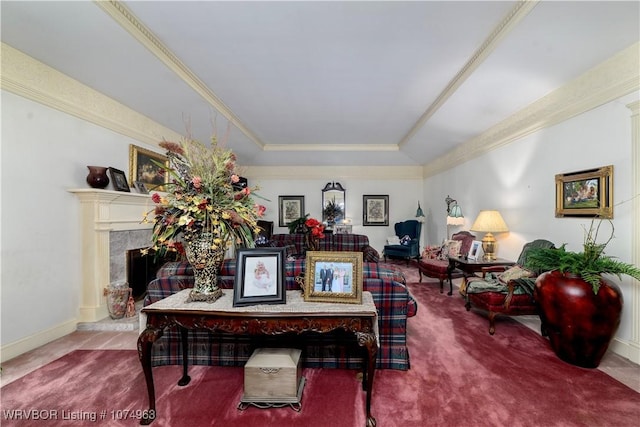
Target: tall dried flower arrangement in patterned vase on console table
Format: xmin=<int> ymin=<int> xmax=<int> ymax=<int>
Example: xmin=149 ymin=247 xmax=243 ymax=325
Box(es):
xmin=145 ymin=131 xmax=266 ymax=302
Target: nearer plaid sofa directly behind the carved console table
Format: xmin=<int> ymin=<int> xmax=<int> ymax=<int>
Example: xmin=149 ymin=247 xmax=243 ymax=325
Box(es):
xmin=144 ymin=259 xmax=417 ymax=370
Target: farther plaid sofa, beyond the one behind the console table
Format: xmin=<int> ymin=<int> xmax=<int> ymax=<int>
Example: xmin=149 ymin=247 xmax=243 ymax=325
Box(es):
xmin=267 ymin=234 xmax=380 ymax=262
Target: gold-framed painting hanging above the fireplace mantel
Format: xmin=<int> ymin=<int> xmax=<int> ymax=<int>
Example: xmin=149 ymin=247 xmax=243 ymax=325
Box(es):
xmin=129 ymin=144 xmax=169 ymax=191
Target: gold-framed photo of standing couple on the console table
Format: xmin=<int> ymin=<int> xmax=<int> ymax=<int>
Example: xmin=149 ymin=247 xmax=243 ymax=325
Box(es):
xmin=304 ymin=251 xmax=362 ymax=304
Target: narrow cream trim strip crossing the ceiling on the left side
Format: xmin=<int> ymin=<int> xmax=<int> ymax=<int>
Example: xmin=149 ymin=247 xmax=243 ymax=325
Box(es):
xmin=94 ymin=0 xmax=264 ymax=149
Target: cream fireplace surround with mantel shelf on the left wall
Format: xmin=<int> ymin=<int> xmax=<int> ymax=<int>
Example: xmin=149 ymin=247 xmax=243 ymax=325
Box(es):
xmin=69 ymin=188 xmax=154 ymax=322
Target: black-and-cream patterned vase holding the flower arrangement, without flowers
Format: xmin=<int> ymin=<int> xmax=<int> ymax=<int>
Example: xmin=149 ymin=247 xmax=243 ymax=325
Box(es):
xmin=185 ymin=233 xmax=225 ymax=302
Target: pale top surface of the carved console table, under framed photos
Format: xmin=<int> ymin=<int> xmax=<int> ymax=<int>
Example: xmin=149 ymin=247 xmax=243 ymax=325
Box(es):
xmin=142 ymin=289 xmax=378 ymax=317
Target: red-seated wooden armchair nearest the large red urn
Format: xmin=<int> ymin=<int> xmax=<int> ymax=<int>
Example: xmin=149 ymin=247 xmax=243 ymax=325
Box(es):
xmin=460 ymin=239 xmax=554 ymax=335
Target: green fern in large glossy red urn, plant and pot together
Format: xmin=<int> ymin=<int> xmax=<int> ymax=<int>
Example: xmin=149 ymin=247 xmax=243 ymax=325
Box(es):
xmin=525 ymin=221 xmax=640 ymax=368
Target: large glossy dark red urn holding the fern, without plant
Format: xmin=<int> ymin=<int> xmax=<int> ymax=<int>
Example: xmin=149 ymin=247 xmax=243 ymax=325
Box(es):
xmin=534 ymin=271 xmax=623 ymax=368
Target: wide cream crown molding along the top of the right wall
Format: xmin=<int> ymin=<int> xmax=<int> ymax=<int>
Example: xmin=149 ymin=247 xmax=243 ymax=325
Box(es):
xmin=424 ymin=42 xmax=640 ymax=178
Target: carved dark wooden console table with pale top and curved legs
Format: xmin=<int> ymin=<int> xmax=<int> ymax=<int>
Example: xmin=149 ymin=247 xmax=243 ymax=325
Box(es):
xmin=138 ymin=289 xmax=378 ymax=427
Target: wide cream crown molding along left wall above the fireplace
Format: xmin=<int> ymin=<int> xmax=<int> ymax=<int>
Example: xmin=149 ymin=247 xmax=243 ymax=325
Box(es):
xmin=0 ymin=43 xmax=181 ymax=147
